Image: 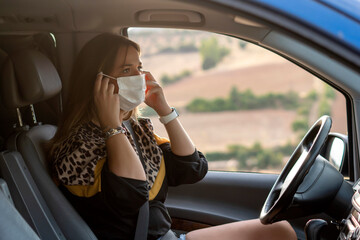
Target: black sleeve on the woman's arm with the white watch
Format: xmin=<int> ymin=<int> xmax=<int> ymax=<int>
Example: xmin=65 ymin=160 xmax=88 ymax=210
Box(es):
xmin=160 ymin=143 xmax=208 ymax=186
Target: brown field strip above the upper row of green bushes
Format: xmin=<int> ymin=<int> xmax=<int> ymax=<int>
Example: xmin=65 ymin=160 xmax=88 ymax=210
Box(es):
xmin=165 ymin=63 xmax=314 ymax=106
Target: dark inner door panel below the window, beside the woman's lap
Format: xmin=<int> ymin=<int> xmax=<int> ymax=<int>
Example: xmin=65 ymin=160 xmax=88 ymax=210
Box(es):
xmin=165 ymin=171 xmax=308 ymax=239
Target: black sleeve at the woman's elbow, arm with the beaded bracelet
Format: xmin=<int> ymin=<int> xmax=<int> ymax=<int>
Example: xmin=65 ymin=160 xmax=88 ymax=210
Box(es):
xmin=101 ymin=163 xmax=149 ymax=213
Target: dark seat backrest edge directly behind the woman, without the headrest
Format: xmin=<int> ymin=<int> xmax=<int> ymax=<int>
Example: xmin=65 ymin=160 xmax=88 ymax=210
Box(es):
xmin=18 ymin=125 xmax=96 ymax=239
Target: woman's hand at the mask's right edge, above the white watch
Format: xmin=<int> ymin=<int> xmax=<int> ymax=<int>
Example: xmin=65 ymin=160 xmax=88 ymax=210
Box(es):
xmin=143 ymin=71 xmax=171 ymax=116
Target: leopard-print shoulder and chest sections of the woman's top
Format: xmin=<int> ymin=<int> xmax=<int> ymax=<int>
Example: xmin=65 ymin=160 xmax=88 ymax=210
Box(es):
xmin=53 ymin=118 xmax=163 ymax=190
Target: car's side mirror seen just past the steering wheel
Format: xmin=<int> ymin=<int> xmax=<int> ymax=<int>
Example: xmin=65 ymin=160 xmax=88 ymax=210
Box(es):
xmin=320 ymin=133 xmax=348 ymax=176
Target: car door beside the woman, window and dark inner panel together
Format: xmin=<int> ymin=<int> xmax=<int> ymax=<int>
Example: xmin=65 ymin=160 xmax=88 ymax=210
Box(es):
xmin=128 ymin=28 xmax=347 ymax=239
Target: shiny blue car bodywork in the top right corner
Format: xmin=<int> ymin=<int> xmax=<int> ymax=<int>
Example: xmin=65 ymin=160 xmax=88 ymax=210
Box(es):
xmin=210 ymin=0 xmax=360 ymax=67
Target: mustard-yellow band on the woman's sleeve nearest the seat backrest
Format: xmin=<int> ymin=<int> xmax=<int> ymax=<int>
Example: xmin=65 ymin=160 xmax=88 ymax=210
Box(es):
xmin=65 ymin=158 xmax=106 ymax=197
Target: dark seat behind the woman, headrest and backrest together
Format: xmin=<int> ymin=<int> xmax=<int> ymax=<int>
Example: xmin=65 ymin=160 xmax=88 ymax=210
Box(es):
xmin=0 ymin=50 xmax=96 ymax=239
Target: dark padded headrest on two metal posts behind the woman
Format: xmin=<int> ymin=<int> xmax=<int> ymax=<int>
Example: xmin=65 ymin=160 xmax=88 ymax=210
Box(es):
xmin=0 ymin=49 xmax=61 ymax=108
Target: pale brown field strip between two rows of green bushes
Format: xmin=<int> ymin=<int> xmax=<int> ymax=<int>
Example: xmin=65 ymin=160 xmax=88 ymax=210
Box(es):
xmin=151 ymin=110 xmax=296 ymax=152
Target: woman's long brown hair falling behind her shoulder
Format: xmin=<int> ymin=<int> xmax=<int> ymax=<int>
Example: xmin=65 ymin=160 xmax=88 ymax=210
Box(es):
xmin=48 ymin=33 xmax=140 ymax=159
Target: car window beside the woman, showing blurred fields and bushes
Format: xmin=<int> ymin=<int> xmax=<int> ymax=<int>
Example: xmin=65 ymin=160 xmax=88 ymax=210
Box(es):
xmin=128 ymin=28 xmax=347 ymax=173
